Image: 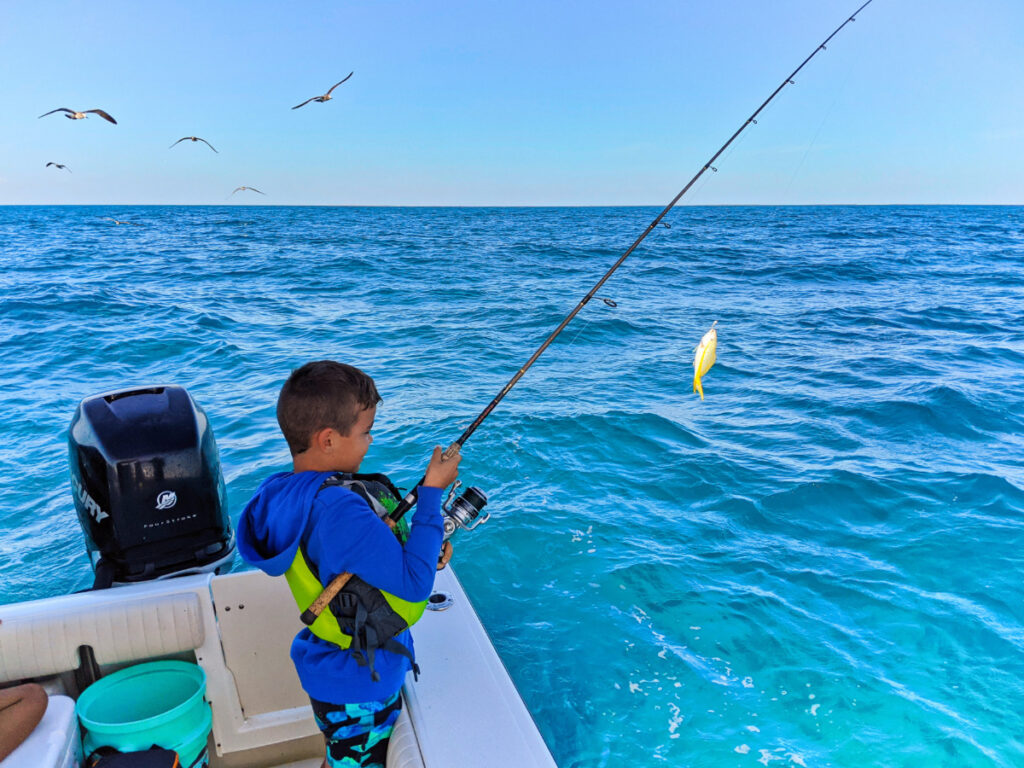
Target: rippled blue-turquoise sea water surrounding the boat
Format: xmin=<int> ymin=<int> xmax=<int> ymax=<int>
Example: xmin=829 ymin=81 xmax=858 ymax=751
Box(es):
xmin=0 ymin=207 xmax=1024 ymax=768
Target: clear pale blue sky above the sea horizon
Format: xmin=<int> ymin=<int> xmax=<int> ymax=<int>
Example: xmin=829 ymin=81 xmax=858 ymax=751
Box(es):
xmin=0 ymin=0 xmax=1024 ymax=205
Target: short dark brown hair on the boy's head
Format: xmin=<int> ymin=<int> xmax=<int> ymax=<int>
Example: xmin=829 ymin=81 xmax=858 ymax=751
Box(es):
xmin=278 ymin=360 xmax=382 ymax=456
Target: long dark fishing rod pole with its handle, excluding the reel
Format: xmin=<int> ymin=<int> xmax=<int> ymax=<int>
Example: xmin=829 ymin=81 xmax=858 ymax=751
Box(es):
xmin=302 ymin=0 xmax=871 ymax=626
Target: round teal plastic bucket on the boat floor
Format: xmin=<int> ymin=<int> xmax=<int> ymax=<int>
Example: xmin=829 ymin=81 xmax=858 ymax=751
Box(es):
xmin=76 ymin=662 xmax=213 ymax=766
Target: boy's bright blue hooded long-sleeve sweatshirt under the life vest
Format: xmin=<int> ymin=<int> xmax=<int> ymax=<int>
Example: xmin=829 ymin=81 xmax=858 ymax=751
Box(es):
xmin=239 ymin=472 xmax=443 ymax=705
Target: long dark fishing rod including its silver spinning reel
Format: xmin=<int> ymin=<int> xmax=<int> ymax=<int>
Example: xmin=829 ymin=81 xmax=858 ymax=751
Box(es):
xmin=302 ymin=0 xmax=871 ymax=625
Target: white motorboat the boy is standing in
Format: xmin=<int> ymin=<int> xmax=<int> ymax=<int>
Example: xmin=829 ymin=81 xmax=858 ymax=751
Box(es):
xmin=0 ymin=386 xmax=555 ymax=768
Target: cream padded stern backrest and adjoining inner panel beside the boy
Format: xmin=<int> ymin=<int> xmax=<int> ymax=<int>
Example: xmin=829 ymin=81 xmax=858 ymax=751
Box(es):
xmin=0 ymin=571 xmax=319 ymax=755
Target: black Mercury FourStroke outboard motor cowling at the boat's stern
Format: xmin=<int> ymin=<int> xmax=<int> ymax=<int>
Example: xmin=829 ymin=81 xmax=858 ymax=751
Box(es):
xmin=68 ymin=386 xmax=234 ymax=587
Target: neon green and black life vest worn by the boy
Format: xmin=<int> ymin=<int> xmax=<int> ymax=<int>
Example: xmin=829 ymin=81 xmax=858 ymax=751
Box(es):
xmin=285 ymin=472 xmax=427 ymax=681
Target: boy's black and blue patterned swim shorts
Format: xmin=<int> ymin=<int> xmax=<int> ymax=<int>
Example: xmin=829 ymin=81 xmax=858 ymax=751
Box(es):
xmin=310 ymin=693 xmax=401 ymax=768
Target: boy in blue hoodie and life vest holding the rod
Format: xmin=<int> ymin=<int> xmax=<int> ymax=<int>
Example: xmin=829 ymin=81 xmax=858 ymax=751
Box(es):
xmin=239 ymin=360 xmax=461 ymax=768
